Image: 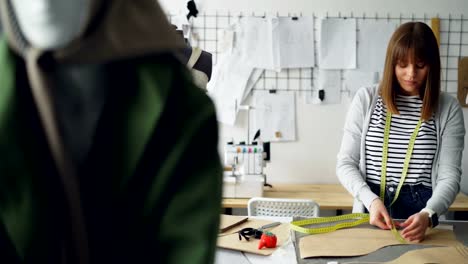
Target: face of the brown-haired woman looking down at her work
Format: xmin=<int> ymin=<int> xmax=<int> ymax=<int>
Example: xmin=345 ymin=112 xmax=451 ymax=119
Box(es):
xmin=395 ymin=58 xmax=429 ymax=95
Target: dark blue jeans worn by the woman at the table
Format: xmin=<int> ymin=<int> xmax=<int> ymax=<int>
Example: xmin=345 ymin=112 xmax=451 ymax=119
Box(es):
xmin=367 ymin=182 xmax=432 ymax=219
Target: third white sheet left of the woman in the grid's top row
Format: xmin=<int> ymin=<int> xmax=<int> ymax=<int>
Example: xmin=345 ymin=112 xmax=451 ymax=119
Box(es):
xmin=273 ymin=17 xmax=315 ymax=69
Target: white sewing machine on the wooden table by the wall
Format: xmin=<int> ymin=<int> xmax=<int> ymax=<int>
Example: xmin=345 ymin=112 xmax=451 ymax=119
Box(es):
xmin=223 ymin=142 xmax=270 ymax=198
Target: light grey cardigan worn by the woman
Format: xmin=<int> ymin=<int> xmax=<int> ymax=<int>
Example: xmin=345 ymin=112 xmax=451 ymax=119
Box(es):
xmin=336 ymin=86 xmax=465 ymax=215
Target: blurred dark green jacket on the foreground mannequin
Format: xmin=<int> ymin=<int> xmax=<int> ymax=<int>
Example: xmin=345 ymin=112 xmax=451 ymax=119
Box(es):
xmin=0 ymin=40 xmax=222 ymax=263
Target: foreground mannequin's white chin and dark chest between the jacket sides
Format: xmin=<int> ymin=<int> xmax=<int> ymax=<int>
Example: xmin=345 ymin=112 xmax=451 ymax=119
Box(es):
xmin=10 ymin=0 xmax=108 ymax=169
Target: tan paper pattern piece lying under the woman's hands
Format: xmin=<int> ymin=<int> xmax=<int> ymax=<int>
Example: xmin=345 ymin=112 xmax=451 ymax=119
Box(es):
xmin=299 ymin=228 xmax=461 ymax=258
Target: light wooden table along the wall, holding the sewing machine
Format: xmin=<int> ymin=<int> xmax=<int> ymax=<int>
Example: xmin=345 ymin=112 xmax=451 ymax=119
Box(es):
xmin=222 ymin=184 xmax=468 ymax=211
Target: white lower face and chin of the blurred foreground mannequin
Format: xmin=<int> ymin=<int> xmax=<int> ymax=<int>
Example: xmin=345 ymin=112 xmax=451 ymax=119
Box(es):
xmin=10 ymin=0 xmax=91 ymax=49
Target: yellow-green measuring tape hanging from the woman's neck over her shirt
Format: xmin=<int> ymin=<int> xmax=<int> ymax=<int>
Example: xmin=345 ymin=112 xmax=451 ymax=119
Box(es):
xmin=380 ymin=110 xmax=422 ymax=207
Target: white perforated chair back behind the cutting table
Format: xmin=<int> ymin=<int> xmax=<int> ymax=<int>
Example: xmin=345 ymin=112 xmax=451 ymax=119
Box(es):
xmin=247 ymin=197 xmax=320 ymax=217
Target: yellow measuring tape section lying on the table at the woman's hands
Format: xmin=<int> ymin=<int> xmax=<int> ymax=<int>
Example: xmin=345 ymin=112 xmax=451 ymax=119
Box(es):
xmin=290 ymin=213 xmax=406 ymax=243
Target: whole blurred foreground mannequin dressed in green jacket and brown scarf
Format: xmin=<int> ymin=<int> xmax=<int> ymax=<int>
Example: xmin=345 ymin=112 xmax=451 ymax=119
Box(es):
xmin=0 ymin=0 xmax=222 ymax=264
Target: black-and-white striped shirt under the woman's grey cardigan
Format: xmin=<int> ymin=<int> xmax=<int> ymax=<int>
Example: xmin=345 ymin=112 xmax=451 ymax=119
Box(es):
xmin=365 ymin=95 xmax=437 ymax=188
